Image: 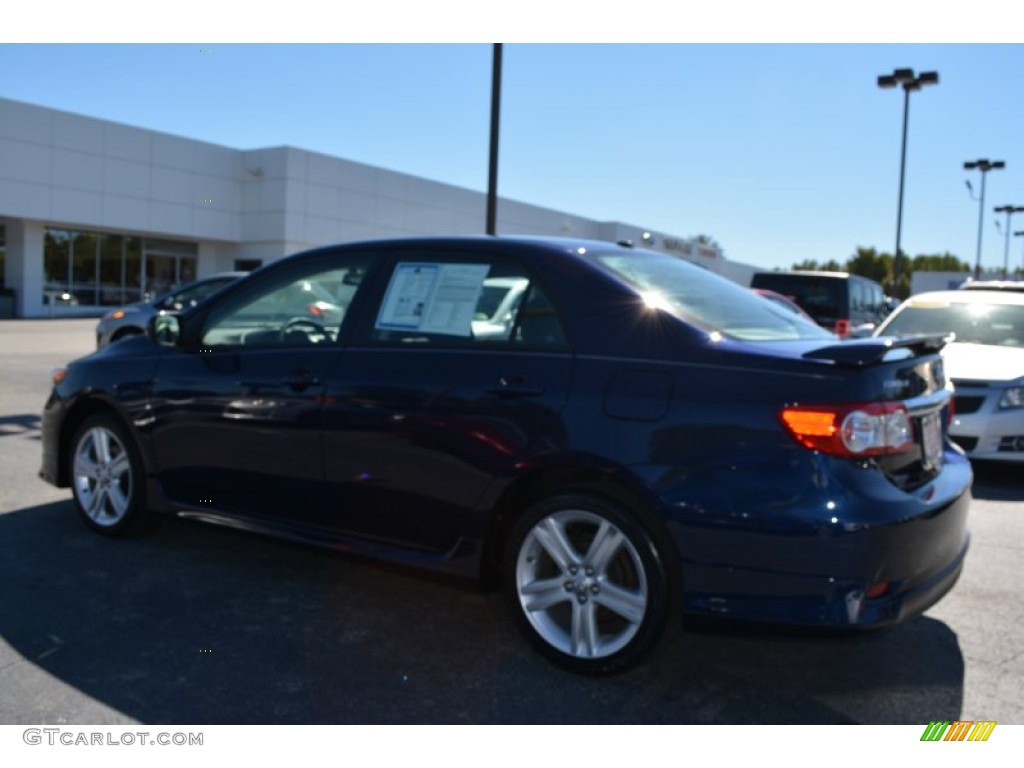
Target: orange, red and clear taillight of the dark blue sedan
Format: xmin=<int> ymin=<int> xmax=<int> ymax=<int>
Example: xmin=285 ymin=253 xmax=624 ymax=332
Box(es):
xmin=779 ymin=402 xmax=913 ymax=458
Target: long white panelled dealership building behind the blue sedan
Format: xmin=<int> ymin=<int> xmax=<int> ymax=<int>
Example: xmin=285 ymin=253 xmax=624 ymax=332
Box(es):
xmin=0 ymin=98 xmax=755 ymax=317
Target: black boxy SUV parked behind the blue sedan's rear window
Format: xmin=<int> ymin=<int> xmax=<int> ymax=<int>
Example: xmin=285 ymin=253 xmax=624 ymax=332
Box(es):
xmin=751 ymin=270 xmax=890 ymax=338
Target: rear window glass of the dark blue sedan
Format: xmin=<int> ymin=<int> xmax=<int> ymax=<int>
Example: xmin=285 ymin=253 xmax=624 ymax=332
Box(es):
xmin=593 ymin=251 xmax=831 ymax=341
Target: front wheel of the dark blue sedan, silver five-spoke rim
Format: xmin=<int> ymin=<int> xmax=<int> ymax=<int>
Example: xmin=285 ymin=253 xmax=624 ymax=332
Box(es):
xmin=71 ymin=414 xmax=145 ymax=536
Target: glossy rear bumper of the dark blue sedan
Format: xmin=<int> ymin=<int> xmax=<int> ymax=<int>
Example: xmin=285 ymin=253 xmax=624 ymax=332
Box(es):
xmin=674 ymin=451 xmax=973 ymax=628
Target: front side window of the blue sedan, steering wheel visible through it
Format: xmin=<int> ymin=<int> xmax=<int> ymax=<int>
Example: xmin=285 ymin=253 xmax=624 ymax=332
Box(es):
xmin=200 ymin=258 xmax=369 ymax=348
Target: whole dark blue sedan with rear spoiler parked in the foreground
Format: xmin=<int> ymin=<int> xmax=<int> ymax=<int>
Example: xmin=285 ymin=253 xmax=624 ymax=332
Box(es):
xmin=41 ymin=238 xmax=972 ymax=673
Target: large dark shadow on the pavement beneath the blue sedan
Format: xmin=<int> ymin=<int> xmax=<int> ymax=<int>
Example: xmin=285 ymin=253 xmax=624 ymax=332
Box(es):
xmin=0 ymin=502 xmax=964 ymax=724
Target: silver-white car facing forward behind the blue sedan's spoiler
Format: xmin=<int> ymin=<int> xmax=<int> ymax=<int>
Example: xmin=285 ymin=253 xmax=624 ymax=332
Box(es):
xmin=874 ymin=289 xmax=1024 ymax=462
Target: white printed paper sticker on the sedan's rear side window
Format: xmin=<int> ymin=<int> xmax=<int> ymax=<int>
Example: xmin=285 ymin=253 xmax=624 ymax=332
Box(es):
xmin=377 ymin=262 xmax=490 ymax=336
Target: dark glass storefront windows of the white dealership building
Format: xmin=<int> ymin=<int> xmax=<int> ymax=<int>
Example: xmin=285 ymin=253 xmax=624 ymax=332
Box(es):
xmin=43 ymin=227 xmax=199 ymax=306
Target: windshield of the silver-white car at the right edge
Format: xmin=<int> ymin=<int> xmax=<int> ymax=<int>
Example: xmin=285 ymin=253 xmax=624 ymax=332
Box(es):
xmin=879 ymin=299 xmax=1024 ymax=347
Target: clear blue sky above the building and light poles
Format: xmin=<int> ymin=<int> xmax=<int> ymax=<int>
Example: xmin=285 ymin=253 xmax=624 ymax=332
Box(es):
xmin=6 ymin=7 xmax=1024 ymax=268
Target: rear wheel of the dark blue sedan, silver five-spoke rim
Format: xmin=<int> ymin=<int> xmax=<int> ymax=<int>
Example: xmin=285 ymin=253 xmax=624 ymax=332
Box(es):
xmin=503 ymin=495 xmax=679 ymax=675
